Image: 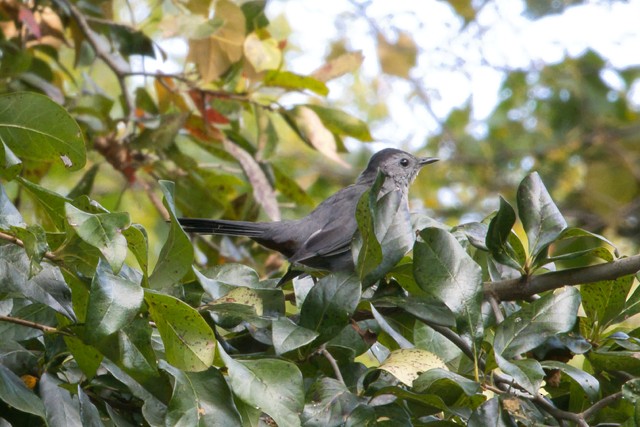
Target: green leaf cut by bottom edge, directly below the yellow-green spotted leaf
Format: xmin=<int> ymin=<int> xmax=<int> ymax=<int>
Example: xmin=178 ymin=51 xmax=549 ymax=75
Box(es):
xmin=160 ymin=360 xmax=241 ymax=427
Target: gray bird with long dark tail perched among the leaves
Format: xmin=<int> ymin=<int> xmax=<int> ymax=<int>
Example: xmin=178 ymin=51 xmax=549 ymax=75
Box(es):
xmin=178 ymin=148 xmax=438 ymax=272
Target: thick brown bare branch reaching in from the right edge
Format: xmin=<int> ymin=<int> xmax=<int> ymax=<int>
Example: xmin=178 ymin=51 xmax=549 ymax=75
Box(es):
xmin=484 ymin=255 xmax=640 ymax=301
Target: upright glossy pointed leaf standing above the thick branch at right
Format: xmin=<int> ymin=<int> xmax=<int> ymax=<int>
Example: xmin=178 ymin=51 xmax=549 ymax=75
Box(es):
xmin=517 ymin=172 xmax=567 ymax=257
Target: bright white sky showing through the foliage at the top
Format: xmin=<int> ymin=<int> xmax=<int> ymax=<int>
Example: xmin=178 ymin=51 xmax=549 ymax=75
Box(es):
xmin=267 ymin=0 xmax=640 ymax=150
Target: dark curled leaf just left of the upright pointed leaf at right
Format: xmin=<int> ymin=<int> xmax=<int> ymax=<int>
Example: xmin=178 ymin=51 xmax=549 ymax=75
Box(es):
xmin=485 ymin=197 xmax=523 ymax=271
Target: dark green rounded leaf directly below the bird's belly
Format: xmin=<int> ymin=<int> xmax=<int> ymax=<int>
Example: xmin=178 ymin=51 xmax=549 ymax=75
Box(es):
xmin=299 ymin=274 xmax=361 ymax=342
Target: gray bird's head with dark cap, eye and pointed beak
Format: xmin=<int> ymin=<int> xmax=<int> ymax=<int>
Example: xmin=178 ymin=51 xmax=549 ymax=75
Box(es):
xmin=358 ymin=148 xmax=439 ymax=183
